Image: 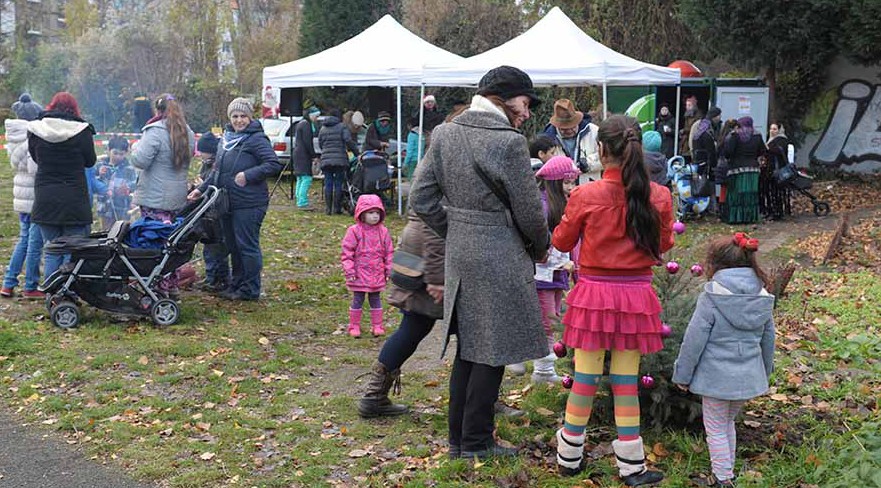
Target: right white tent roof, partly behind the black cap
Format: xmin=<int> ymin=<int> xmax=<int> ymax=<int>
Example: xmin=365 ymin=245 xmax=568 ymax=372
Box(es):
xmin=423 ymin=7 xmax=680 ymax=86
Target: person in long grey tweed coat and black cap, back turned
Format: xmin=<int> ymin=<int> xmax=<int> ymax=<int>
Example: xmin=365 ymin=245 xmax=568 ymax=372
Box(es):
xmin=410 ymin=66 xmax=548 ymax=458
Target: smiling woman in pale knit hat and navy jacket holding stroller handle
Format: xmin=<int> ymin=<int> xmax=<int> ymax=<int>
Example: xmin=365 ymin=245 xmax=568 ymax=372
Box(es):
xmin=188 ymin=98 xmax=283 ymax=300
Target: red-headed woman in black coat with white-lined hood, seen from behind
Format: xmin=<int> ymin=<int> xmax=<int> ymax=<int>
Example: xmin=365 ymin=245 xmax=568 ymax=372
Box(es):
xmin=28 ymin=92 xmax=98 ymax=278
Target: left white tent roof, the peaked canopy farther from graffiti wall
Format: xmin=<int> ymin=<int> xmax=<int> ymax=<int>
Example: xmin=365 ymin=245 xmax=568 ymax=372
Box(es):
xmin=263 ymin=15 xmax=463 ymax=88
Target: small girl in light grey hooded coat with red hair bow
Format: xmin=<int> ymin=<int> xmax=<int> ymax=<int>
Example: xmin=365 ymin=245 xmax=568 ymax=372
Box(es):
xmin=673 ymin=232 xmax=774 ymax=486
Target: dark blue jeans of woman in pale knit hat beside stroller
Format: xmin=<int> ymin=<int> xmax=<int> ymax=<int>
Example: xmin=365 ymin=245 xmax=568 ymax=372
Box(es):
xmin=221 ymin=207 xmax=267 ymax=299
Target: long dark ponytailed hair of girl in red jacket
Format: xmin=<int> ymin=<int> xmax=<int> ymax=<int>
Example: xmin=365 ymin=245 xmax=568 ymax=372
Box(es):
xmin=597 ymin=115 xmax=661 ymax=260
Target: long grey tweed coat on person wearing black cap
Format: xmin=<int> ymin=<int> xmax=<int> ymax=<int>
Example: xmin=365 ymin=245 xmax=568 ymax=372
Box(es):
xmin=410 ymin=109 xmax=549 ymax=366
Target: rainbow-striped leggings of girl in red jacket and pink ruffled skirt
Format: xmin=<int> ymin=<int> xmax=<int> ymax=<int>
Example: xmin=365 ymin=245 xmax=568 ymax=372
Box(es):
xmin=563 ymin=349 xmax=640 ymax=441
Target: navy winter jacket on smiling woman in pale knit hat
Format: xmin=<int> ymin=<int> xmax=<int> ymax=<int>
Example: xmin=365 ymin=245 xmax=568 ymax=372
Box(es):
xmin=199 ymin=120 xmax=284 ymax=210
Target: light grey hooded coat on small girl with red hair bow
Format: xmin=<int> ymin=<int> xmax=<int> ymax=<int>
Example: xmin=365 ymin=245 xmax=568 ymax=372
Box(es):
xmin=673 ymin=268 xmax=774 ymax=400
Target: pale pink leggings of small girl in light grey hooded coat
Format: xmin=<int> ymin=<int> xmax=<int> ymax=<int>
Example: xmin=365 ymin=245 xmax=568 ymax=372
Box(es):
xmin=703 ymin=396 xmax=746 ymax=481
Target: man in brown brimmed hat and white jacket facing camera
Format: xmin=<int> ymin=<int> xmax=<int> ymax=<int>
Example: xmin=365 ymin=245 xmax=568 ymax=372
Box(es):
xmin=544 ymin=98 xmax=603 ymax=184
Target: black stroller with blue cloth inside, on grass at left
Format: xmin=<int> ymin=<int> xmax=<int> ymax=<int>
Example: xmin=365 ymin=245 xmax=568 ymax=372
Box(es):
xmin=40 ymin=186 xmax=219 ymax=329
